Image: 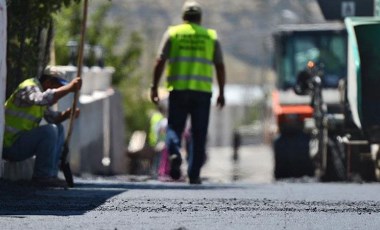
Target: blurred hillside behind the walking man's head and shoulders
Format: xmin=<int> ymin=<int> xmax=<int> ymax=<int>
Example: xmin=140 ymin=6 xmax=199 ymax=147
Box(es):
xmin=90 ymin=0 xmax=323 ymax=84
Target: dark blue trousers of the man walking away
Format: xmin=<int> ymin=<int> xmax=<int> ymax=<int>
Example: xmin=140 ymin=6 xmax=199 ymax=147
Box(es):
xmin=166 ymin=90 xmax=211 ymax=179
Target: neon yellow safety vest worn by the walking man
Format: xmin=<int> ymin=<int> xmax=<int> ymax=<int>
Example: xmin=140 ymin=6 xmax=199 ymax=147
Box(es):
xmin=167 ymin=23 xmax=217 ymax=92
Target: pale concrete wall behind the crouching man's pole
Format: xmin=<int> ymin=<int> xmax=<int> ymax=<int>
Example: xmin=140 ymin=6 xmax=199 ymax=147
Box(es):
xmin=57 ymin=66 xmax=128 ymax=174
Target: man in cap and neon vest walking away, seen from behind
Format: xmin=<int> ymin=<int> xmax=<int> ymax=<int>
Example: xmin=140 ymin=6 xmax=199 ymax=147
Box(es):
xmin=151 ymin=1 xmax=225 ymax=184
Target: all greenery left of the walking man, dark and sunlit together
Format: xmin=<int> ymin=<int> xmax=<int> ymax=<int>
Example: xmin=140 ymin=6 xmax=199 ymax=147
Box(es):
xmin=7 ymin=0 xmax=152 ymax=140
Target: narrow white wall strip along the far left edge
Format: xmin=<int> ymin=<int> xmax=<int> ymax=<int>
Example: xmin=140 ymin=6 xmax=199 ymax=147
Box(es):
xmin=0 ymin=0 xmax=7 ymax=177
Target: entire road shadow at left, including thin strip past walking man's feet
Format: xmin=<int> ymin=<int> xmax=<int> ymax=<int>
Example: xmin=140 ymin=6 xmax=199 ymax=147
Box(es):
xmin=0 ymin=180 xmax=243 ymax=218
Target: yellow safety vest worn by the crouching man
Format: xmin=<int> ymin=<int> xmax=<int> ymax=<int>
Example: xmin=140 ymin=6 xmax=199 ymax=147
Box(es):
xmin=4 ymin=78 xmax=47 ymax=147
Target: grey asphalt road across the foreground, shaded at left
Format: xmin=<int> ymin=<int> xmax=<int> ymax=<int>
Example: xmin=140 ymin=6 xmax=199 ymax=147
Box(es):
xmin=0 ymin=146 xmax=380 ymax=230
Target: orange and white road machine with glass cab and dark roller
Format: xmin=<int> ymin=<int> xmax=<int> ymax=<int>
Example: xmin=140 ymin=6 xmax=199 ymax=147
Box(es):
xmin=272 ymin=23 xmax=347 ymax=178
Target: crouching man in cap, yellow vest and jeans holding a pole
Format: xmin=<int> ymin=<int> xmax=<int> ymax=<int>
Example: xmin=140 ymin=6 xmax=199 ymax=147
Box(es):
xmin=3 ymin=67 xmax=82 ymax=187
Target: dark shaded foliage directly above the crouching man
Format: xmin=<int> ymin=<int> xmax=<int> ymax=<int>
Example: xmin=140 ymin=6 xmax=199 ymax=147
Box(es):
xmin=6 ymin=0 xmax=80 ymax=97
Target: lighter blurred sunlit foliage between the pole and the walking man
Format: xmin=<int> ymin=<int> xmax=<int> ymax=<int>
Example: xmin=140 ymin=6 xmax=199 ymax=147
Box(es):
xmin=54 ymin=3 xmax=152 ymax=139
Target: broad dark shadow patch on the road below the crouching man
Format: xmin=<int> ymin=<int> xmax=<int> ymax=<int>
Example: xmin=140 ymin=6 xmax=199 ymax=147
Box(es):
xmin=0 ymin=181 xmax=123 ymax=216
